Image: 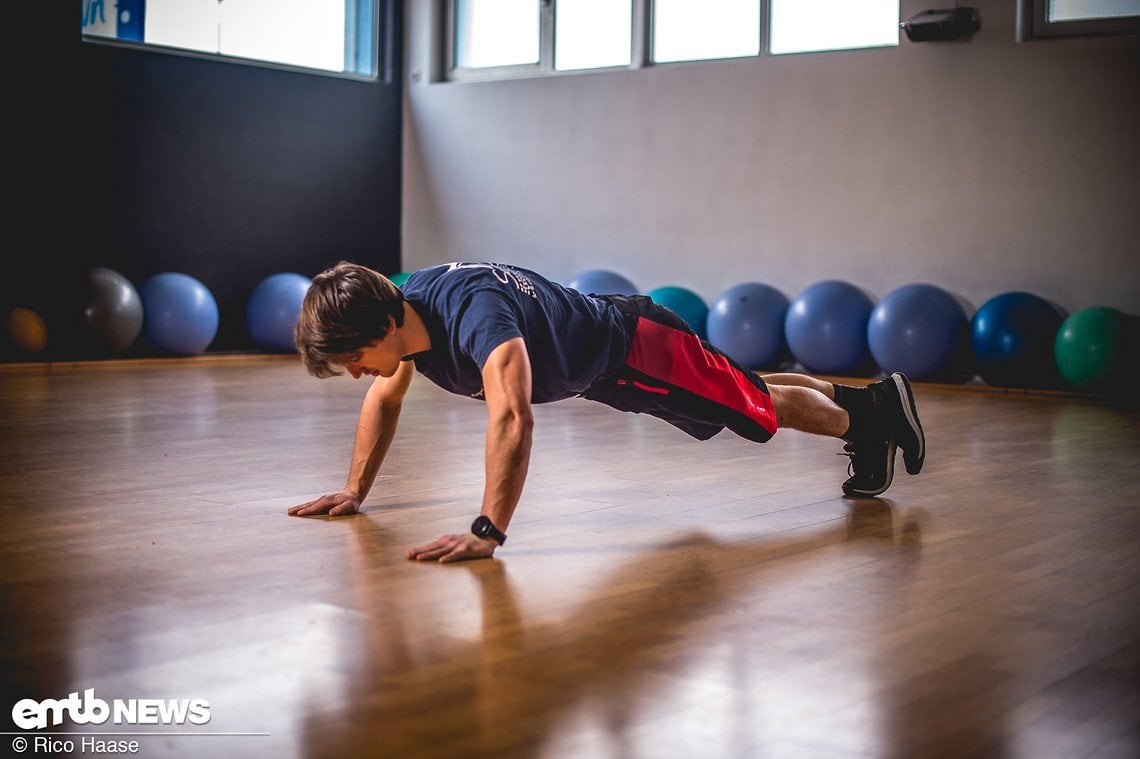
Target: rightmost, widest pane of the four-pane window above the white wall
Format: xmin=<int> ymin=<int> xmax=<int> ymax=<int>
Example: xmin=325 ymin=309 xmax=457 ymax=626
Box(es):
xmin=768 ymin=0 xmax=898 ymax=55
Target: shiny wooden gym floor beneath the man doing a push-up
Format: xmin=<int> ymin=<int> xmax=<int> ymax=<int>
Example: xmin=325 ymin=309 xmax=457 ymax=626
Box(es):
xmin=0 ymin=358 xmax=1140 ymax=759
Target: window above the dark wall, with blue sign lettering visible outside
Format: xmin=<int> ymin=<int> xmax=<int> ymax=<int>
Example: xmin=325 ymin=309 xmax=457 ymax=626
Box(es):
xmin=81 ymin=0 xmax=378 ymax=77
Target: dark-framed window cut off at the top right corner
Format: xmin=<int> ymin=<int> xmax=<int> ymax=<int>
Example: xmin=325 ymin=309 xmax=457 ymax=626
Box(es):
xmin=1017 ymin=0 xmax=1140 ymax=42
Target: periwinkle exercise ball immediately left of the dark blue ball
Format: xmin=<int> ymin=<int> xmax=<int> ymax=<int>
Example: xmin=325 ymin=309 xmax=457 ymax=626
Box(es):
xmin=866 ymin=284 xmax=968 ymax=380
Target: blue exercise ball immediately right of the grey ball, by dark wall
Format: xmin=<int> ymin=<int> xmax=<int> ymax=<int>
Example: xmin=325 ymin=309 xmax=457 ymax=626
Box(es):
xmin=139 ymin=271 xmax=218 ymax=356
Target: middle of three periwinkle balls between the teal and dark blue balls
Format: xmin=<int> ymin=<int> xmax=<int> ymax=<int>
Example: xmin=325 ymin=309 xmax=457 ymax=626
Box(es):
xmin=784 ymin=279 xmax=874 ymax=374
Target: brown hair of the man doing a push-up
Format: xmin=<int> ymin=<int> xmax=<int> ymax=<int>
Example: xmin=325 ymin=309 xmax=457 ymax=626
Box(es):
xmin=293 ymin=261 xmax=404 ymax=378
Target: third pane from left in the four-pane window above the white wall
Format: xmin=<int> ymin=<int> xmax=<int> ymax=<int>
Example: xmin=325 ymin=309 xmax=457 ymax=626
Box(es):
xmin=653 ymin=0 xmax=760 ymax=63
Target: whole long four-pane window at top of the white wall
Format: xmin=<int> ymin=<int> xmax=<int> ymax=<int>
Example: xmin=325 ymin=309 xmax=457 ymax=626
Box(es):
xmin=443 ymin=0 xmax=898 ymax=80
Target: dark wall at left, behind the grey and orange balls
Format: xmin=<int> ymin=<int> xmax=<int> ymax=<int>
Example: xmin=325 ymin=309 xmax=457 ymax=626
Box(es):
xmin=2 ymin=2 xmax=402 ymax=360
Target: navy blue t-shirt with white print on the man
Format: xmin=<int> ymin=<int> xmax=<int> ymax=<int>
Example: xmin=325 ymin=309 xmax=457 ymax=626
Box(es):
xmin=401 ymin=263 xmax=629 ymax=403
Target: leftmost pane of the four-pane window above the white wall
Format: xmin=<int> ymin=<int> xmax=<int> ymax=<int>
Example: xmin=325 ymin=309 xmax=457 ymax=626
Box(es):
xmin=455 ymin=0 xmax=539 ymax=68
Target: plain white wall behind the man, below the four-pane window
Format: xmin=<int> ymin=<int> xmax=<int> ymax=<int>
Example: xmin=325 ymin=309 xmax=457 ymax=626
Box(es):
xmin=402 ymin=0 xmax=1140 ymax=313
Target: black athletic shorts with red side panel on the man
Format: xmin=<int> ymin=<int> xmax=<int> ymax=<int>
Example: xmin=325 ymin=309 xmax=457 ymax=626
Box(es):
xmin=581 ymin=295 xmax=776 ymax=442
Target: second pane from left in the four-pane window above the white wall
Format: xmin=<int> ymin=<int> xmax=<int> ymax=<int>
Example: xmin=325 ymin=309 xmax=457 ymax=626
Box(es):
xmin=554 ymin=0 xmax=633 ymax=71
